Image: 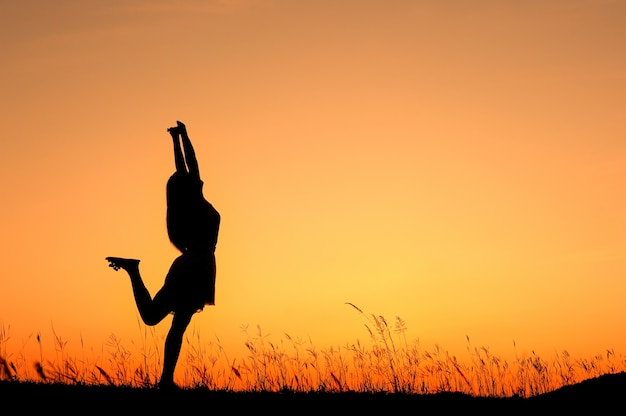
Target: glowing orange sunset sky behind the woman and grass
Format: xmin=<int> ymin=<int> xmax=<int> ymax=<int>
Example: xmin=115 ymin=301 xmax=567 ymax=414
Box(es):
xmin=0 ymin=0 xmax=626 ymax=370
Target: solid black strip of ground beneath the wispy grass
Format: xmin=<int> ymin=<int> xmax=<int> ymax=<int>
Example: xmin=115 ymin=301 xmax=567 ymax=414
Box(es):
xmin=0 ymin=372 xmax=626 ymax=416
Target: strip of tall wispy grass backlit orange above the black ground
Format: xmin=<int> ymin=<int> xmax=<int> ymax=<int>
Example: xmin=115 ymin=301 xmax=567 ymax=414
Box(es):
xmin=0 ymin=303 xmax=626 ymax=397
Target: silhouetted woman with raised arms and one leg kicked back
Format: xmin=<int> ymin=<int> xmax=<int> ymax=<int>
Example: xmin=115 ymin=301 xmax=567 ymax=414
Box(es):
xmin=106 ymin=121 xmax=220 ymax=388
